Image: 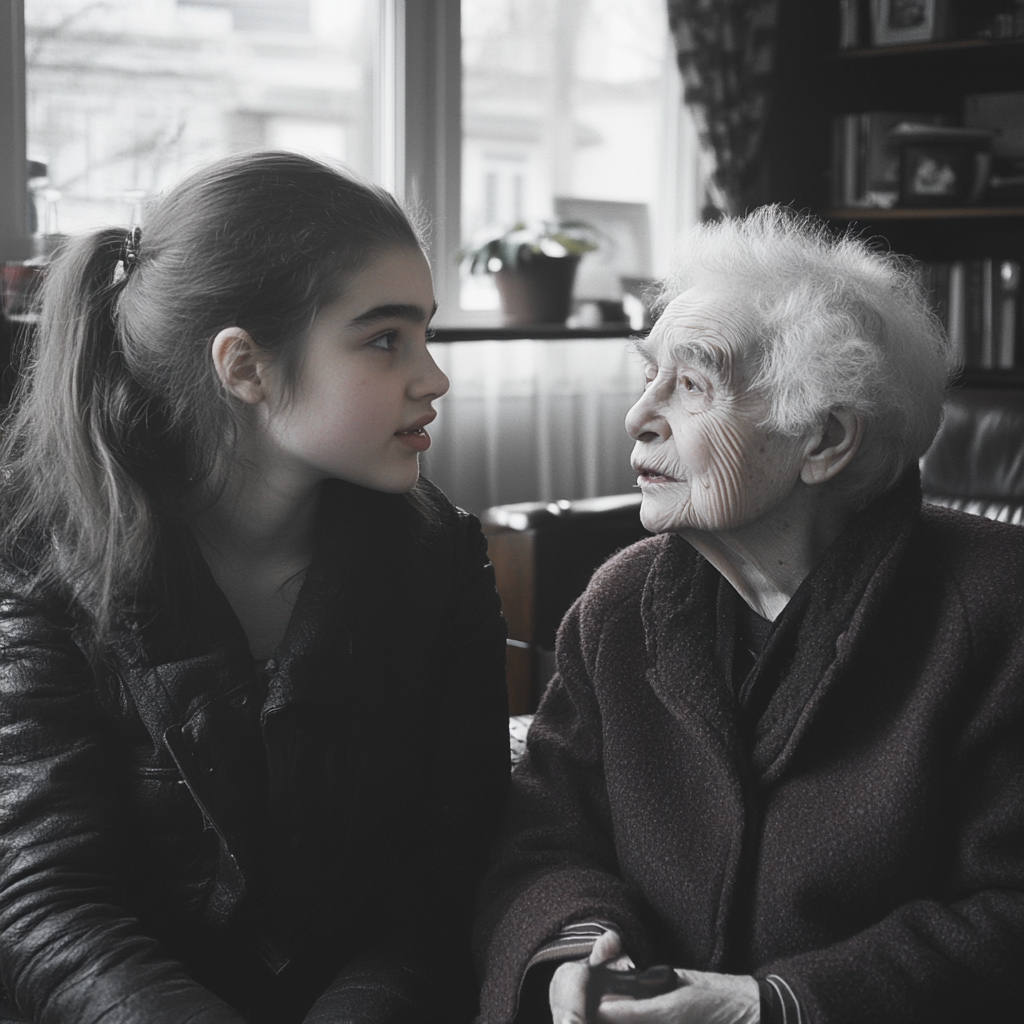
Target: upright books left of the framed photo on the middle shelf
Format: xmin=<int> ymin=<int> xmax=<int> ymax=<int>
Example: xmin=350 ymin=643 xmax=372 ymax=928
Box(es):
xmin=831 ymin=111 xmax=945 ymax=209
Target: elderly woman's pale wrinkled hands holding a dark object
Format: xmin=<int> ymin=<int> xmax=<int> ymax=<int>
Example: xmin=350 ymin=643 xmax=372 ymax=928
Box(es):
xmin=550 ymin=932 xmax=761 ymax=1024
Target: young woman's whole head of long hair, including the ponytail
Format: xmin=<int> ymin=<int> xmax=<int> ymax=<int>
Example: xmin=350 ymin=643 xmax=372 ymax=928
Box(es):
xmin=0 ymin=153 xmax=420 ymax=635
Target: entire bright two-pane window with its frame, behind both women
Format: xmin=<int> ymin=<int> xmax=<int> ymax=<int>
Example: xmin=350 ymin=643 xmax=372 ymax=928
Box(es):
xmin=0 ymin=0 xmax=698 ymax=325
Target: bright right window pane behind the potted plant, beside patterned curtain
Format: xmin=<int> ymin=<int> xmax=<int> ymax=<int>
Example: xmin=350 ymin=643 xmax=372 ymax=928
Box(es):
xmin=462 ymin=0 xmax=679 ymax=308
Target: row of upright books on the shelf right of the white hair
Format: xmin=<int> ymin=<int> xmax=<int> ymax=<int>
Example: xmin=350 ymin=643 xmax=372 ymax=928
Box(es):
xmin=920 ymin=257 xmax=1024 ymax=370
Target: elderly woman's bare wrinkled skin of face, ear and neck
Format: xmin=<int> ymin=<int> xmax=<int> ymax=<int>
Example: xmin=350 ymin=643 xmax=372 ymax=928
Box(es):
xmin=626 ymin=289 xmax=863 ymax=620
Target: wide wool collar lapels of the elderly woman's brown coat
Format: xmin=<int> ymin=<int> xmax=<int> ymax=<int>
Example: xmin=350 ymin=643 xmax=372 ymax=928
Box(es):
xmin=641 ymin=466 xmax=921 ymax=784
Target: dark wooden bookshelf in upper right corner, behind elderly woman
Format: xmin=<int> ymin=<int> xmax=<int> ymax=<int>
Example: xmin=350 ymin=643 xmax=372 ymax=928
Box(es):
xmin=764 ymin=0 xmax=1024 ymax=388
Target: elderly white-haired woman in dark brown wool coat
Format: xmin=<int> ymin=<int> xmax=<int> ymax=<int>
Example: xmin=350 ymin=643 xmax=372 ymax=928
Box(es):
xmin=477 ymin=210 xmax=1024 ymax=1024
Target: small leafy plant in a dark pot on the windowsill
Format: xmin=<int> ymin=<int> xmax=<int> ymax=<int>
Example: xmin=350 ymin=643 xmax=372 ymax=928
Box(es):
xmin=462 ymin=220 xmax=600 ymax=324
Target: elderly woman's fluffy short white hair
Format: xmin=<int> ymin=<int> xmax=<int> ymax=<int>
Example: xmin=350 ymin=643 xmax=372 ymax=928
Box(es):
xmin=659 ymin=206 xmax=956 ymax=503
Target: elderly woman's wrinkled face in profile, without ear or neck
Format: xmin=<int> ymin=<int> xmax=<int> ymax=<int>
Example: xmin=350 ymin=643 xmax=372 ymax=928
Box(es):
xmin=626 ymin=289 xmax=805 ymax=532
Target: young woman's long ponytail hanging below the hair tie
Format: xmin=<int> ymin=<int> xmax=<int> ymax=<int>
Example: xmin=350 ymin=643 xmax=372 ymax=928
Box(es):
xmin=0 ymin=229 xmax=153 ymax=623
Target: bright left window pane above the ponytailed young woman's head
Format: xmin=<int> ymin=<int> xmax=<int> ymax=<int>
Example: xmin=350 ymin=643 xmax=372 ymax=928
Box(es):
xmin=25 ymin=0 xmax=379 ymax=232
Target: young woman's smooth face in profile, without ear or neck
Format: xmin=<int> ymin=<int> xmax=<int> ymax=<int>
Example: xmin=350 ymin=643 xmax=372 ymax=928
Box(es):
xmin=258 ymin=248 xmax=449 ymax=494
